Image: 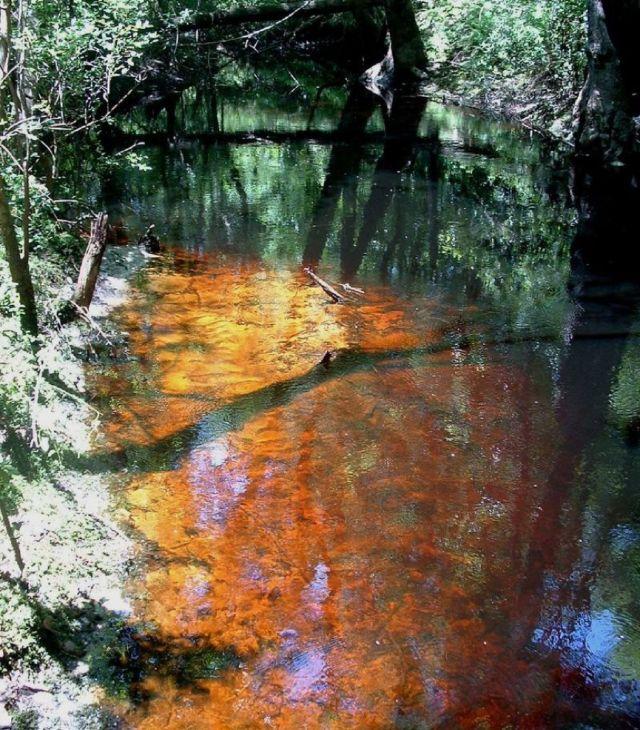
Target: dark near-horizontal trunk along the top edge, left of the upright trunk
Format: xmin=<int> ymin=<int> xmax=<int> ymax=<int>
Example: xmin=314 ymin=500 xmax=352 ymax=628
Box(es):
xmin=175 ymin=0 xmax=384 ymax=33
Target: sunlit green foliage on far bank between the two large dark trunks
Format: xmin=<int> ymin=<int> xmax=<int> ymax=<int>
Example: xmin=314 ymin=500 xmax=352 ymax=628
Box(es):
xmin=420 ymin=0 xmax=586 ymax=120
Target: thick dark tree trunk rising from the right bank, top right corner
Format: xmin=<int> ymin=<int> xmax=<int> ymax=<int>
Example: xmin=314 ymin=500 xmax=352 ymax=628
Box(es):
xmin=574 ymin=0 xmax=640 ymax=164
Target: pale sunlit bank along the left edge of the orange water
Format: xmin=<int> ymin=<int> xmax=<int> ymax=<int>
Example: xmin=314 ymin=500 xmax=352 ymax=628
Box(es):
xmin=0 ymin=247 xmax=144 ymax=730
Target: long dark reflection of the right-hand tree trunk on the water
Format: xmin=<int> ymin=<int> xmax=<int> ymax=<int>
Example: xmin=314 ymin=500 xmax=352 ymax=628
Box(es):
xmin=502 ymin=166 xmax=640 ymax=728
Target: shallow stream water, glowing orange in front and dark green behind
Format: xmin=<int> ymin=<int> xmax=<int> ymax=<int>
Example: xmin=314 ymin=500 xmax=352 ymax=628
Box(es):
xmin=96 ymin=88 xmax=640 ymax=728
